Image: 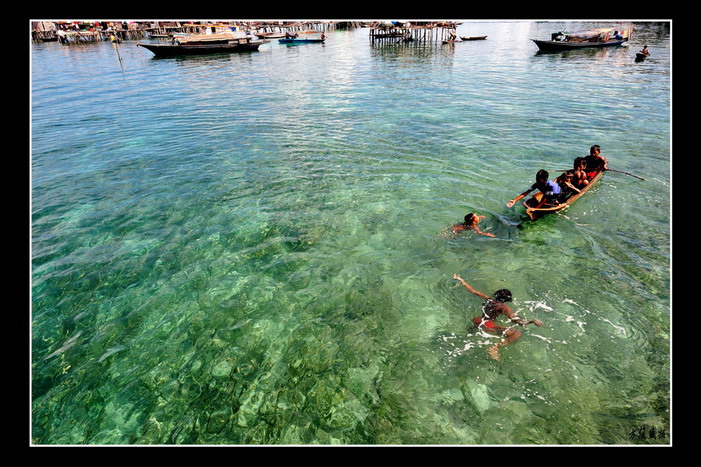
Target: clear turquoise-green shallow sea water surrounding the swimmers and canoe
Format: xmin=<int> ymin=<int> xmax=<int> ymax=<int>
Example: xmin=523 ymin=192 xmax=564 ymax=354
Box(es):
xmin=31 ymin=22 xmax=671 ymax=444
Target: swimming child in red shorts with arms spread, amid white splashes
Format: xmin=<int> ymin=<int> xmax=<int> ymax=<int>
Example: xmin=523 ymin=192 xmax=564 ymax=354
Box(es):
xmin=453 ymin=274 xmax=543 ymax=360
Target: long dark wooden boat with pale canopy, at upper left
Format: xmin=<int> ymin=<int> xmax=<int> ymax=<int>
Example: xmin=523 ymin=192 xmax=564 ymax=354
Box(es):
xmin=136 ymin=34 xmax=263 ymax=57
